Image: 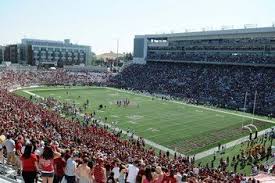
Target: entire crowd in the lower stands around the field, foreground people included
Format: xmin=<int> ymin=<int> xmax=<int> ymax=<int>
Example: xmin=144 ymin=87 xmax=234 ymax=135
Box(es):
xmin=0 ymin=64 xmax=274 ymax=183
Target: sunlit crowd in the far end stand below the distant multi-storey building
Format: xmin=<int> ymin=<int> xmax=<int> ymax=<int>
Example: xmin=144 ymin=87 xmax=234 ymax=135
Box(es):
xmin=0 ymin=69 xmax=109 ymax=89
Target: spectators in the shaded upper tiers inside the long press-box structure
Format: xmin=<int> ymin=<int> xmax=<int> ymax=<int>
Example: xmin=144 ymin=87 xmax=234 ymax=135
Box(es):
xmin=147 ymin=38 xmax=275 ymax=65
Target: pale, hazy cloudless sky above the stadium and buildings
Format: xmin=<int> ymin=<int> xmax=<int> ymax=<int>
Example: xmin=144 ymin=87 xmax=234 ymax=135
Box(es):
xmin=0 ymin=0 xmax=275 ymax=54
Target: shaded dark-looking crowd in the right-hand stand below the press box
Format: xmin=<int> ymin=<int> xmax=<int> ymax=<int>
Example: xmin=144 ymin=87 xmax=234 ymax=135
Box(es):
xmin=111 ymin=63 xmax=275 ymax=114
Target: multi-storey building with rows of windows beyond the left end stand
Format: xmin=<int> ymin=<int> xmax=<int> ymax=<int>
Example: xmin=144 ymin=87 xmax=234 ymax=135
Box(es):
xmin=5 ymin=39 xmax=91 ymax=66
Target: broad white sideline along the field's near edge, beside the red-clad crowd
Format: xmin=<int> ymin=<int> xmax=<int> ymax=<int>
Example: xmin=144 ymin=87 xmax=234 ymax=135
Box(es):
xmin=23 ymin=90 xmax=181 ymax=156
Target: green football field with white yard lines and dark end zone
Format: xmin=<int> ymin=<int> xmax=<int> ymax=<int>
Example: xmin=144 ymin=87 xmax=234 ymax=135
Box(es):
xmin=17 ymin=87 xmax=274 ymax=155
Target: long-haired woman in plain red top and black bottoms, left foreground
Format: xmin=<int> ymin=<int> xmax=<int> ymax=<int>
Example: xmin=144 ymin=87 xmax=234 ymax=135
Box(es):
xmin=20 ymin=144 xmax=38 ymax=183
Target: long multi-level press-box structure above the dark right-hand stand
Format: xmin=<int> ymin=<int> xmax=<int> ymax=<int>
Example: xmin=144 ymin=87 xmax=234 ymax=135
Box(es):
xmin=133 ymin=27 xmax=275 ymax=66
